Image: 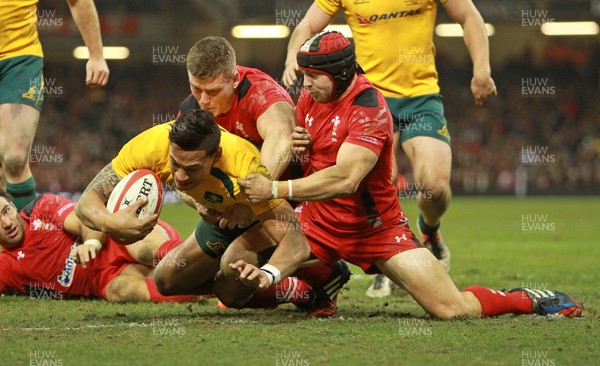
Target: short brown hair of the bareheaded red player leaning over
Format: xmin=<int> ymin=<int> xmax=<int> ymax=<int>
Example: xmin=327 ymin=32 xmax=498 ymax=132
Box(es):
xmin=186 ymin=36 xmax=237 ymax=79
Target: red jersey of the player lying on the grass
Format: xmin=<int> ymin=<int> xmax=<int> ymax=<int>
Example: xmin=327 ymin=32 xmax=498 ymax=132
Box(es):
xmin=0 ymin=194 xmax=99 ymax=299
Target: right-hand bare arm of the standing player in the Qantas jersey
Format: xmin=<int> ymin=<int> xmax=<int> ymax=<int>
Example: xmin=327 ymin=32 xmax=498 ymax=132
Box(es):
xmin=446 ymin=0 xmax=497 ymax=105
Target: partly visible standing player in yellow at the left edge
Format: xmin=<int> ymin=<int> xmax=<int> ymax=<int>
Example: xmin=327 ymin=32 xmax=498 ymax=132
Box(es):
xmin=0 ymin=0 xmax=109 ymax=210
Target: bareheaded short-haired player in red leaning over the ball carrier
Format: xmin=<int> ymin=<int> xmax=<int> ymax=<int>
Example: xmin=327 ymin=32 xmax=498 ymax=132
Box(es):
xmin=179 ymin=37 xmax=295 ymax=178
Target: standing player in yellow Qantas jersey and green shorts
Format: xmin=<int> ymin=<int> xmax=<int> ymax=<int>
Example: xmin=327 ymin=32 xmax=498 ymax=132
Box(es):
xmin=283 ymin=0 xmax=496 ymax=297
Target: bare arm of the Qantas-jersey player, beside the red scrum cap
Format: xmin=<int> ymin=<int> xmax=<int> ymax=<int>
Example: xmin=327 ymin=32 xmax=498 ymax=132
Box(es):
xmin=282 ymin=3 xmax=334 ymax=88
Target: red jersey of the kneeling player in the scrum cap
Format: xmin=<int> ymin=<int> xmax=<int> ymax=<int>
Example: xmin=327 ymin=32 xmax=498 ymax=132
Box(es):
xmin=296 ymin=75 xmax=406 ymax=232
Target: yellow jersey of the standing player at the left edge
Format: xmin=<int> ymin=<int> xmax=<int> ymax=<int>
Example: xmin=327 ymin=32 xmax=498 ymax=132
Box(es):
xmin=0 ymin=0 xmax=43 ymax=60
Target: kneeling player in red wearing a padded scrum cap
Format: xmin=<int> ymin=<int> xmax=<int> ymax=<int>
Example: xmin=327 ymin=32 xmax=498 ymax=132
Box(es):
xmin=236 ymin=32 xmax=582 ymax=319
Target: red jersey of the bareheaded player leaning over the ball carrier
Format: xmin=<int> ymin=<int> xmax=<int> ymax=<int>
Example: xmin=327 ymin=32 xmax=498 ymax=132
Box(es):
xmin=179 ymin=65 xmax=294 ymax=148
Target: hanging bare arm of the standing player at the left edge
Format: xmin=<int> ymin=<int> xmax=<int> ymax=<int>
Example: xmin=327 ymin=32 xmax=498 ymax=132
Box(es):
xmin=67 ymin=0 xmax=110 ymax=86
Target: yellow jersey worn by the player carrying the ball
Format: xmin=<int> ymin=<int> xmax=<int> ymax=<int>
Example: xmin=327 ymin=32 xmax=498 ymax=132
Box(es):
xmin=112 ymin=121 xmax=282 ymax=215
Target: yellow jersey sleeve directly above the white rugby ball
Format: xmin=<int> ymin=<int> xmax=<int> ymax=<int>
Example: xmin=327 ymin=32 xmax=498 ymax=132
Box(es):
xmin=112 ymin=121 xmax=174 ymax=183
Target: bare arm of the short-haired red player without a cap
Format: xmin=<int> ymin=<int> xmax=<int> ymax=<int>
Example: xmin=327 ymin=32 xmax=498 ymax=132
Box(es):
xmin=256 ymin=102 xmax=296 ymax=179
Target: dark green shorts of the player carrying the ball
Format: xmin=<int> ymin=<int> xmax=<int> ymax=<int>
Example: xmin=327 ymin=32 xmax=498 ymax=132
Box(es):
xmin=194 ymin=220 xmax=258 ymax=259
